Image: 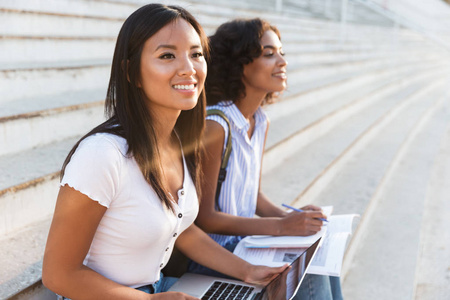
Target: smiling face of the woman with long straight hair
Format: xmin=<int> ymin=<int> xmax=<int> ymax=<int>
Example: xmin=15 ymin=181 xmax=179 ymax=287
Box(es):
xmin=138 ymin=18 xmax=206 ymax=111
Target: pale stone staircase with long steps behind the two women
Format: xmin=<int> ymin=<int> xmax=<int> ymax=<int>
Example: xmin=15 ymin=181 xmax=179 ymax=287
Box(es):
xmin=0 ymin=0 xmax=450 ymax=299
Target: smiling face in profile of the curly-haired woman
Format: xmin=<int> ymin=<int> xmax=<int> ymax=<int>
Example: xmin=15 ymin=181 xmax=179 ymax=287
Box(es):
xmin=243 ymin=30 xmax=287 ymax=94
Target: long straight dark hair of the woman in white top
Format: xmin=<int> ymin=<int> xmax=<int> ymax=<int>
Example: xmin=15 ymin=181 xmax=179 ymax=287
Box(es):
xmin=61 ymin=4 xmax=208 ymax=210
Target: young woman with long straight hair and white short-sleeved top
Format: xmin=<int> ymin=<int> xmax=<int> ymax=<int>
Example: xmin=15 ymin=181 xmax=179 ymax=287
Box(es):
xmin=42 ymin=4 xmax=284 ymax=299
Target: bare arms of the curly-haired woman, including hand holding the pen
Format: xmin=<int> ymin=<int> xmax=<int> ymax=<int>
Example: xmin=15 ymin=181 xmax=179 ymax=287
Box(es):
xmin=196 ymin=120 xmax=325 ymax=236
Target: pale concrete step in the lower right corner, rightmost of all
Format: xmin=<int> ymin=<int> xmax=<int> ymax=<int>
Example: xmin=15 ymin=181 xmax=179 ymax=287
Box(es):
xmin=411 ymin=121 xmax=450 ymax=300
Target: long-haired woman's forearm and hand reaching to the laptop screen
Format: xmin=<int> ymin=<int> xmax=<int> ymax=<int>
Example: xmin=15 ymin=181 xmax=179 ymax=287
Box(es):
xmin=175 ymin=224 xmax=287 ymax=285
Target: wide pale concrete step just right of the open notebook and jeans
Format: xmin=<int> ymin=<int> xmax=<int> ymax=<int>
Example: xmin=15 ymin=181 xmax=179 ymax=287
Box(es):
xmin=340 ymin=88 xmax=450 ymax=300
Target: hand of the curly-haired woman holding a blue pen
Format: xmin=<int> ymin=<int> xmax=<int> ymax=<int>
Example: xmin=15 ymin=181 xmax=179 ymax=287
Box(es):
xmin=278 ymin=210 xmax=326 ymax=236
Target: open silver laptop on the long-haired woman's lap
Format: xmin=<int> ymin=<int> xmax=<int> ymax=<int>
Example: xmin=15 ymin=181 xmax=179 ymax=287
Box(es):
xmin=169 ymin=238 xmax=321 ymax=300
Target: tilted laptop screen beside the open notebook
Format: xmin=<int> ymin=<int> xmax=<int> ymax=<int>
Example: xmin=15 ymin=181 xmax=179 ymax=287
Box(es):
xmin=257 ymin=238 xmax=321 ymax=300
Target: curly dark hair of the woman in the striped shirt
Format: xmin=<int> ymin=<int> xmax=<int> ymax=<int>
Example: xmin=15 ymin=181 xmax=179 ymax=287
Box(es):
xmin=206 ymin=18 xmax=281 ymax=105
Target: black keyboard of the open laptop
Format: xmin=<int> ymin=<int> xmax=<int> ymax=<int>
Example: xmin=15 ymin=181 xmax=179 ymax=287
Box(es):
xmin=202 ymin=281 xmax=254 ymax=300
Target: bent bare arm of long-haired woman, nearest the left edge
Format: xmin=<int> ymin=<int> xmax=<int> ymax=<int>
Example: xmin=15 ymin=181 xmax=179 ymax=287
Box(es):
xmin=42 ymin=185 xmax=195 ymax=299
